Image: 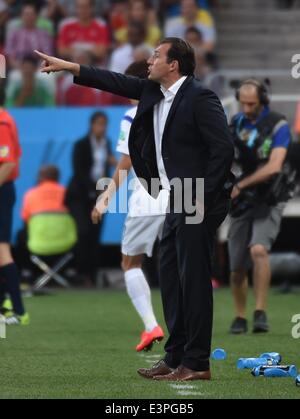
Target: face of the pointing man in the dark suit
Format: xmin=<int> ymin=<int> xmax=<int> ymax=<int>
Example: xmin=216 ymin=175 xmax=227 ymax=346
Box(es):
xmin=148 ymin=44 xmax=174 ymax=83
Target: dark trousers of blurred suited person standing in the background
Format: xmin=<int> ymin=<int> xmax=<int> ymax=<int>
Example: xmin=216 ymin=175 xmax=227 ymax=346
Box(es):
xmin=68 ymin=200 xmax=101 ymax=279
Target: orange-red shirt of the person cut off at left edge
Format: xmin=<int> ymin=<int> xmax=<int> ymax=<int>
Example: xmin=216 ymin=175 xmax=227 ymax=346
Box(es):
xmin=0 ymin=110 xmax=22 ymax=182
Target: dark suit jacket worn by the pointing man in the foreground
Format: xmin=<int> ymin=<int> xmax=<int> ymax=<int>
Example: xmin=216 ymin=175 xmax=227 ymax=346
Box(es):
xmin=74 ymin=66 xmax=234 ymax=206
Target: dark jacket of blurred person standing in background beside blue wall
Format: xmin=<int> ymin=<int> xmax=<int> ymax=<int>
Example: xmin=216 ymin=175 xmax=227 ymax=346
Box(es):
xmin=66 ymin=135 xmax=110 ymax=204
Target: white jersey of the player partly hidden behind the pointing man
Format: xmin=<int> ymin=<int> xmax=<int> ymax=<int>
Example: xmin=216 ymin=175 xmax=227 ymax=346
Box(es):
xmin=117 ymin=107 xmax=169 ymax=217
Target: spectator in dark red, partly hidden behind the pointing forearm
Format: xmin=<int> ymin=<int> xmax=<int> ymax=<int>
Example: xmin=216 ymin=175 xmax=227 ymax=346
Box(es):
xmin=57 ymin=51 xmax=129 ymax=106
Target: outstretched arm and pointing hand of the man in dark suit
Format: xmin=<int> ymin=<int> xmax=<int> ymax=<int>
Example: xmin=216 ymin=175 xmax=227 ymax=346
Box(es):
xmin=35 ymin=51 xmax=147 ymax=100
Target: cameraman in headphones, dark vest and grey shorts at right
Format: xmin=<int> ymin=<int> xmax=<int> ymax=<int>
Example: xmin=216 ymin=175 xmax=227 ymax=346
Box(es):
xmin=229 ymin=79 xmax=294 ymax=334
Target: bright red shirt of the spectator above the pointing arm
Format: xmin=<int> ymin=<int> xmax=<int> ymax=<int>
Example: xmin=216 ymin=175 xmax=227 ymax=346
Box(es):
xmin=58 ymin=19 xmax=110 ymax=48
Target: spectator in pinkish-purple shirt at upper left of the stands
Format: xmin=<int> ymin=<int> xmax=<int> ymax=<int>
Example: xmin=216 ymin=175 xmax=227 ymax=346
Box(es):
xmin=5 ymin=3 xmax=53 ymax=67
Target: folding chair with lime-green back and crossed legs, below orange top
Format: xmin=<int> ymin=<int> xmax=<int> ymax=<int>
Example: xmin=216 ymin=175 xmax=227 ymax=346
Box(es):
xmin=27 ymin=212 xmax=77 ymax=290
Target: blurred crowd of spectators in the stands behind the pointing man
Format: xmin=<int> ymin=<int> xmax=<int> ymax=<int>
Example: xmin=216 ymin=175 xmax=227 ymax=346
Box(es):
xmin=0 ymin=0 xmax=218 ymax=107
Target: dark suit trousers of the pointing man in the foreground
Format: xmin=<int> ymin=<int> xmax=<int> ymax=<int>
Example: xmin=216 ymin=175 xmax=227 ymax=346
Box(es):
xmin=160 ymin=199 xmax=229 ymax=371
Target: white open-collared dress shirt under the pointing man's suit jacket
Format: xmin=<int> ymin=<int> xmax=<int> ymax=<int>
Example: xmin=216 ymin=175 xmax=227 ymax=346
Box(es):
xmin=153 ymin=76 xmax=187 ymax=190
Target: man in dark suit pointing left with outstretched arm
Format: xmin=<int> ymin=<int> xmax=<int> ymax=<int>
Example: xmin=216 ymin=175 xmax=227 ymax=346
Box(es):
xmin=35 ymin=38 xmax=234 ymax=381
